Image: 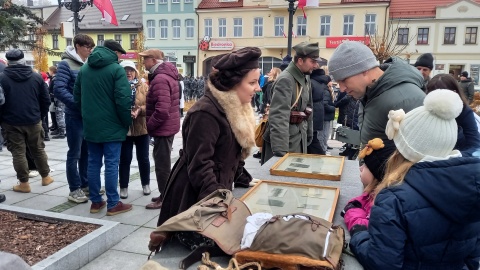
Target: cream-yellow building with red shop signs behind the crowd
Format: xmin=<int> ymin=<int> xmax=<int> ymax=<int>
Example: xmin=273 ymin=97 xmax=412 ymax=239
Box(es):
xmin=197 ymin=0 xmax=389 ymax=76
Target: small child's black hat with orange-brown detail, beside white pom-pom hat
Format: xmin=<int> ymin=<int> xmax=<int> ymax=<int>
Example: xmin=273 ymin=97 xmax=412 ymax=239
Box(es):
xmin=358 ymin=138 xmax=396 ymax=181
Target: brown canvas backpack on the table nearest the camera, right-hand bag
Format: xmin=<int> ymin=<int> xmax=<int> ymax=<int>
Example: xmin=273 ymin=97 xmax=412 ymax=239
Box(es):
xmin=244 ymin=214 xmax=345 ymax=269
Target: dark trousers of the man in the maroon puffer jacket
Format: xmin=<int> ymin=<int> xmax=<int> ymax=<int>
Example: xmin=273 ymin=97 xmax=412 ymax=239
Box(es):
xmin=153 ymin=135 xmax=174 ymax=194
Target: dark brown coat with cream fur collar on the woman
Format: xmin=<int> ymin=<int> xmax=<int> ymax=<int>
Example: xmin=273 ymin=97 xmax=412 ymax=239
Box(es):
xmin=158 ymin=83 xmax=255 ymax=226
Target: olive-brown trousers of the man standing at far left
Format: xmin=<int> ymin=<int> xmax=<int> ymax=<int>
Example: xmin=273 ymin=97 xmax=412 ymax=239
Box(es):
xmin=2 ymin=121 xmax=50 ymax=183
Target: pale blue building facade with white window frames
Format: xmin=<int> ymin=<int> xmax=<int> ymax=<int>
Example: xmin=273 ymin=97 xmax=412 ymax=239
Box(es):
xmin=142 ymin=0 xmax=198 ymax=76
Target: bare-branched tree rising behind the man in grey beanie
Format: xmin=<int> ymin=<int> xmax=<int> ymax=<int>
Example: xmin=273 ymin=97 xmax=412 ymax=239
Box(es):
xmin=365 ymin=20 xmax=416 ymax=64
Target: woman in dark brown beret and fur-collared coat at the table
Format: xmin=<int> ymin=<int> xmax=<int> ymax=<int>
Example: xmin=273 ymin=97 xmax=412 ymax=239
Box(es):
xmin=158 ymin=47 xmax=261 ymax=226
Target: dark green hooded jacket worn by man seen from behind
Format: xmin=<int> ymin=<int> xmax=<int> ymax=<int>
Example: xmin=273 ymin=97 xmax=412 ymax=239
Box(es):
xmin=73 ymin=46 xmax=132 ymax=143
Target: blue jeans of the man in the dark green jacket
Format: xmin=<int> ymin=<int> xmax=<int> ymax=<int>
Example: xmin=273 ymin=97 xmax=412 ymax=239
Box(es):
xmin=87 ymin=142 xmax=122 ymax=209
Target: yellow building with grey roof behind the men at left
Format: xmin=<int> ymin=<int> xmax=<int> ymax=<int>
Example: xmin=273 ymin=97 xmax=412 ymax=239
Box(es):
xmin=45 ymin=0 xmax=143 ymax=65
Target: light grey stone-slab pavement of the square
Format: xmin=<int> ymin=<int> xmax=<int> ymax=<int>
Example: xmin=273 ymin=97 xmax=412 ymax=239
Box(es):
xmin=0 ymin=115 xmax=342 ymax=270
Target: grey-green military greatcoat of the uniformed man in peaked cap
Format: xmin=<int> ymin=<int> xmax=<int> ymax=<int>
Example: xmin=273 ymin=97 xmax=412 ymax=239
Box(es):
xmin=263 ymin=62 xmax=313 ymax=161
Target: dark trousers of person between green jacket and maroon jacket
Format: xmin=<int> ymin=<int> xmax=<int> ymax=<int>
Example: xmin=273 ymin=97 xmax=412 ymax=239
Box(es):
xmin=118 ymin=134 xmax=150 ymax=188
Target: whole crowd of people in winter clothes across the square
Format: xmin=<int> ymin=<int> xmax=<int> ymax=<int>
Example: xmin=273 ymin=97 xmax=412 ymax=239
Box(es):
xmin=0 ymin=34 xmax=480 ymax=269
